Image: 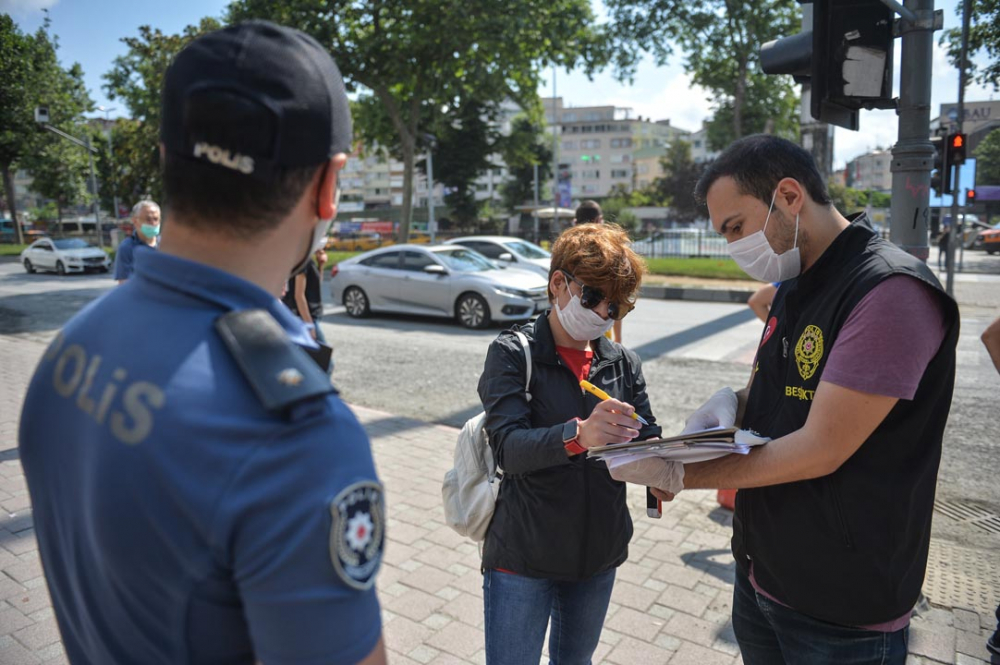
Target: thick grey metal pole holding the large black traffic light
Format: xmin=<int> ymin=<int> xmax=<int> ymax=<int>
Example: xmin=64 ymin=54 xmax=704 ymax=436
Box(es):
xmin=889 ymin=0 xmax=939 ymax=268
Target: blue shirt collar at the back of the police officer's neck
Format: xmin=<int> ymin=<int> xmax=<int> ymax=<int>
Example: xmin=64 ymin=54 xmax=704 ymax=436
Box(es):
xmin=135 ymin=252 xmax=318 ymax=348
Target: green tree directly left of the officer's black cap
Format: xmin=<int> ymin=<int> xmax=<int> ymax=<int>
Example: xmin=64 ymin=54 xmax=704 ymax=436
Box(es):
xmin=98 ymin=18 xmax=222 ymax=206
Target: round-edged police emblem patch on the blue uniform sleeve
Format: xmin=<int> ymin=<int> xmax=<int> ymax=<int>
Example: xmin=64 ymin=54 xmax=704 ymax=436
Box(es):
xmin=330 ymin=481 xmax=385 ymax=590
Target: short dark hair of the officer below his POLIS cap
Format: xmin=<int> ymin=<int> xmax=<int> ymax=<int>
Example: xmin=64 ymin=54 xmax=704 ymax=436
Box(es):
xmin=163 ymin=94 xmax=322 ymax=238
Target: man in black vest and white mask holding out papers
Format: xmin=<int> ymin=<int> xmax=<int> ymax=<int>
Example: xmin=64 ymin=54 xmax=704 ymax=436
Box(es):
xmin=619 ymin=135 xmax=958 ymax=665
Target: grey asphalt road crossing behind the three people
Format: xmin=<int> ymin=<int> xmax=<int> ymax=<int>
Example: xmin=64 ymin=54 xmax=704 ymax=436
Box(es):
xmin=0 ymin=254 xmax=1000 ymax=548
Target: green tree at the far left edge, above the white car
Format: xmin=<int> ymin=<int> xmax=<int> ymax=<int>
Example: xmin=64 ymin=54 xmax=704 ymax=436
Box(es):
xmin=0 ymin=14 xmax=91 ymax=242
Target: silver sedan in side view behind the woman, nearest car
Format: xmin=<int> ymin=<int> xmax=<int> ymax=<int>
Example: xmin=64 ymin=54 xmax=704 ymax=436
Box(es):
xmin=330 ymin=244 xmax=548 ymax=328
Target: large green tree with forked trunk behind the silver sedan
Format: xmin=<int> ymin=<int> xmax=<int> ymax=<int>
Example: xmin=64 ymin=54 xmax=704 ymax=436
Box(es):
xmin=229 ymin=0 xmax=609 ymax=241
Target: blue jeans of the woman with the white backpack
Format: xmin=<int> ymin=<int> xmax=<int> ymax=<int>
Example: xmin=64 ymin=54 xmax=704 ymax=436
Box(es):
xmin=483 ymin=568 xmax=615 ymax=665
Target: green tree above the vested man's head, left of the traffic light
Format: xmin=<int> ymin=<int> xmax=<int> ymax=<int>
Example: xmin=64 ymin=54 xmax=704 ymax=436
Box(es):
xmin=605 ymin=0 xmax=799 ymax=150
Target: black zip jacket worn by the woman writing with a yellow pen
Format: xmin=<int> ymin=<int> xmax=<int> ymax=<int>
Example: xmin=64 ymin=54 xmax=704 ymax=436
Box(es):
xmin=479 ymin=316 xmax=660 ymax=581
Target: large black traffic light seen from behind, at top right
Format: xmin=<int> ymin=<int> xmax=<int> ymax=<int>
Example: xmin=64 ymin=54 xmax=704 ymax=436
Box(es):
xmin=760 ymin=0 xmax=895 ymax=130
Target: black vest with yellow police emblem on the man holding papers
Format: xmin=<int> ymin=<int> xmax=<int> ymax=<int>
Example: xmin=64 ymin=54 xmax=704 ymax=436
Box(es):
xmin=733 ymin=219 xmax=958 ymax=626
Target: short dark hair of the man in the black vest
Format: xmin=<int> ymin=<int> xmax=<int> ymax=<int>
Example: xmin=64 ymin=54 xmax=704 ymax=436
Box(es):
xmin=694 ymin=134 xmax=831 ymax=205
